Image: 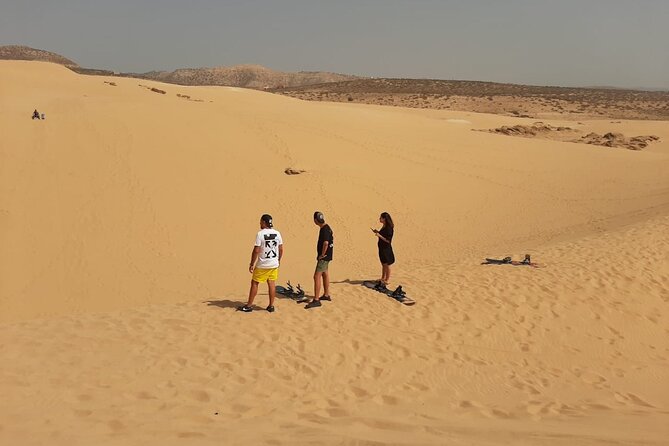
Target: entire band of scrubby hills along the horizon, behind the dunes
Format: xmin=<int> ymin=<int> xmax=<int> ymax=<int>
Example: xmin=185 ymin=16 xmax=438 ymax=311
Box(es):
xmin=0 ymin=45 xmax=669 ymax=120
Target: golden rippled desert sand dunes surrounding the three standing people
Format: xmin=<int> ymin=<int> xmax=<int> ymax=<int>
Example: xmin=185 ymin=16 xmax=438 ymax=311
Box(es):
xmin=0 ymin=61 xmax=669 ymax=445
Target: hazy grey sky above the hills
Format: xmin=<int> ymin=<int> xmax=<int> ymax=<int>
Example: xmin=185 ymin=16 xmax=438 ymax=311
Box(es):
xmin=0 ymin=0 xmax=669 ymax=88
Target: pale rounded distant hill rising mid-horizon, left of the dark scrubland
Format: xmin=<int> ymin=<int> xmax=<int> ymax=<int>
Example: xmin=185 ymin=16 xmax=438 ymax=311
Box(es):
xmin=130 ymin=65 xmax=358 ymax=89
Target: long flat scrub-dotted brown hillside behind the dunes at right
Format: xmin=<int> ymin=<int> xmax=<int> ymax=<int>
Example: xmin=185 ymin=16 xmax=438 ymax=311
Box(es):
xmin=271 ymin=78 xmax=669 ymax=120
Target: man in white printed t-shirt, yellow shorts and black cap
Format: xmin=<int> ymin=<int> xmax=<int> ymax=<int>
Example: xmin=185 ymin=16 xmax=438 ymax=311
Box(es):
xmin=238 ymin=214 xmax=283 ymax=313
